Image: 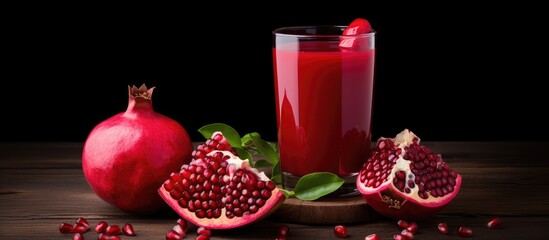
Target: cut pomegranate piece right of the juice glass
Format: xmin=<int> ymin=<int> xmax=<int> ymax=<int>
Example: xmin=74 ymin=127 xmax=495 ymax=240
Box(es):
xmin=356 ymin=129 xmax=461 ymax=220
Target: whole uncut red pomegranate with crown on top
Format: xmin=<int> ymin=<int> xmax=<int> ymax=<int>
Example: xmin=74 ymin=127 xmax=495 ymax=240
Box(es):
xmin=82 ymin=84 xmax=193 ymax=214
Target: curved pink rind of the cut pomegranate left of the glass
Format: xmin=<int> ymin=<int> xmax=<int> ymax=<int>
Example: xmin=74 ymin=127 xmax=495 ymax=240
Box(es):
xmin=158 ymin=187 xmax=286 ymax=229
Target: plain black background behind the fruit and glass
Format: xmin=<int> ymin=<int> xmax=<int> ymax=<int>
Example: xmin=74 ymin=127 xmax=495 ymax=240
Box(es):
xmin=0 ymin=2 xmax=549 ymax=141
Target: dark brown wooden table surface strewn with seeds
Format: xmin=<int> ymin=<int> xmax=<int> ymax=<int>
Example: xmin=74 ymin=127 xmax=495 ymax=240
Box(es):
xmin=0 ymin=142 xmax=549 ymax=240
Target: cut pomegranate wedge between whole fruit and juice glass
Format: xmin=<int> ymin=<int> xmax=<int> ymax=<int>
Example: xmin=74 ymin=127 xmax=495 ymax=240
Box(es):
xmin=158 ymin=132 xmax=285 ymax=229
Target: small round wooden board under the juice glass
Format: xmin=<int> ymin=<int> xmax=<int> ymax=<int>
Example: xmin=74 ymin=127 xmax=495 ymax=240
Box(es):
xmin=272 ymin=196 xmax=378 ymax=225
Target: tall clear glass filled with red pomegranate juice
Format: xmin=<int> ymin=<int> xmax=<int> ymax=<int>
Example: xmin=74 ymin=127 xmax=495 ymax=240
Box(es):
xmin=272 ymin=26 xmax=375 ymax=196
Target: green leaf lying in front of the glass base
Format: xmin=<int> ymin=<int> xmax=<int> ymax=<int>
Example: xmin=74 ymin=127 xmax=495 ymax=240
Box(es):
xmin=294 ymin=172 xmax=344 ymax=201
